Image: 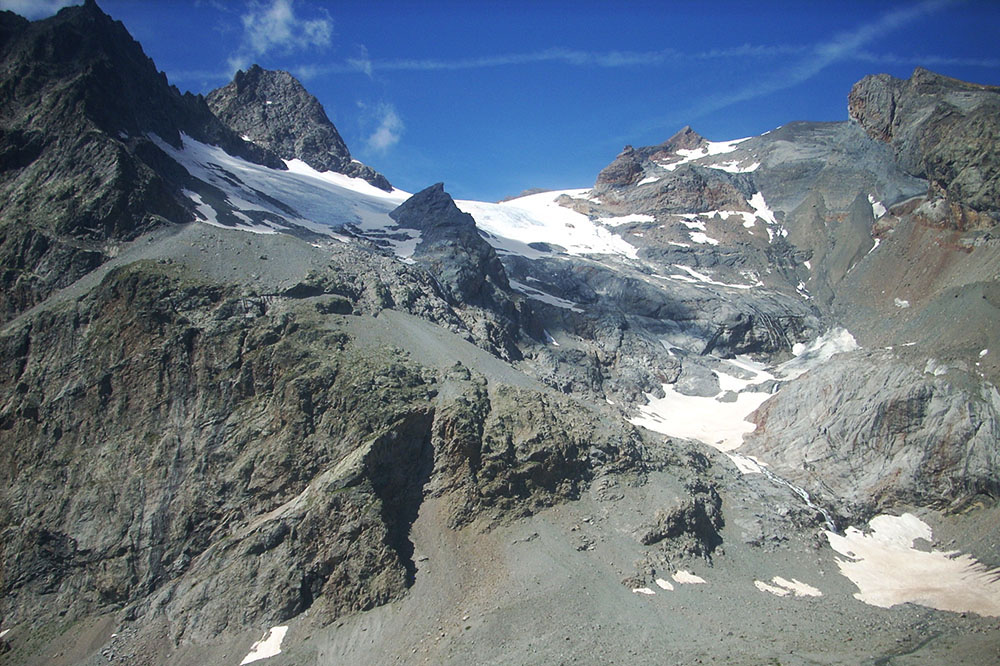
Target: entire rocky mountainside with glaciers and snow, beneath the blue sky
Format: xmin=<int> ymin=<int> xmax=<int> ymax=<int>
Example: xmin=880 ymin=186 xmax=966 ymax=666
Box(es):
xmin=0 ymin=2 xmax=1000 ymax=664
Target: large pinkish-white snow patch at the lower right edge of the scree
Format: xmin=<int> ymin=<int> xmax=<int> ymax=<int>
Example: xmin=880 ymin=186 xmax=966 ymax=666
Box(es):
xmin=826 ymin=513 xmax=1000 ymax=617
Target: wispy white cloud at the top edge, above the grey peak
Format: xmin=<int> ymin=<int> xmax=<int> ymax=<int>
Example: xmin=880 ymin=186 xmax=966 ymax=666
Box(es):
xmin=229 ymin=0 xmax=333 ymax=70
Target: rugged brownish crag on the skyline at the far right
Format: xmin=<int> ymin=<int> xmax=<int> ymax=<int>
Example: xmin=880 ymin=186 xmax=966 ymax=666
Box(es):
xmin=848 ymin=68 xmax=1000 ymax=211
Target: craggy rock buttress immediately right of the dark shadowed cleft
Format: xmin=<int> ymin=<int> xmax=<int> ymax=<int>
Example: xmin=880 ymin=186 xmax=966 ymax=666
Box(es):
xmin=429 ymin=365 xmax=655 ymax=527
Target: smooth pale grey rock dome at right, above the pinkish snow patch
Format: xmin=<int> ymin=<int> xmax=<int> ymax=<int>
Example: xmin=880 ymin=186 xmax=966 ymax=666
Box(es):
xmin=741 ymin=352 xmax=1000 ymax=522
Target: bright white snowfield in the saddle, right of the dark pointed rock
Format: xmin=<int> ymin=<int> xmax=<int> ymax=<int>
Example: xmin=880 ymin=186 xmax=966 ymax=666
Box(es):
xmin=455 ymin=190 xmax=638 ymax=259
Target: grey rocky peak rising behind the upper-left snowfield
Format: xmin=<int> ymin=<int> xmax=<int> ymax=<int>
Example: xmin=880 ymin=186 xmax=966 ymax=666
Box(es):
xmin=206 ymin=65 xmax=392 ymax=192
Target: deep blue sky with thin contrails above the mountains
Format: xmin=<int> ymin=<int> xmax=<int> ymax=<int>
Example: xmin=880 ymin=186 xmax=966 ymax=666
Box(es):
xmin=0 ymin=0 xmax=1000 ymax=200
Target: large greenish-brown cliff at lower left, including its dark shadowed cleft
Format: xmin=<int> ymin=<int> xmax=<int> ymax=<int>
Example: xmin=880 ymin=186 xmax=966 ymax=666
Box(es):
xmin=0 ymin=245 xmax=660 ymax=641
